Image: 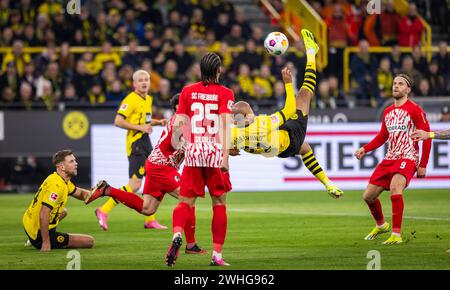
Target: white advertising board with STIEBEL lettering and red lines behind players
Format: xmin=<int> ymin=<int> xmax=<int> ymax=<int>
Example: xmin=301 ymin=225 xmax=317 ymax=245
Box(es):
xmin=91 ymin=123 xmax=450 ymax=191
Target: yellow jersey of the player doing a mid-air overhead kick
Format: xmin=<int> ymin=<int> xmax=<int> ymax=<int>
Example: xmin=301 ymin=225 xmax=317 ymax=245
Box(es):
xmin=230 ymin=83 xmax=296 ymax=157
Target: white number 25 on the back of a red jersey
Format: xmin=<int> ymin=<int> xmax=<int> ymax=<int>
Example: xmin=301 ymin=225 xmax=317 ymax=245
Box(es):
xmin=191 ymin=103 xmax=219 ymax=134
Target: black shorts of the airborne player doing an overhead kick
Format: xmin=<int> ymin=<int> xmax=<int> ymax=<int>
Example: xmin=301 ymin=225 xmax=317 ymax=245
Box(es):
xmin=278 ymin=110 xmax=308 ymax=158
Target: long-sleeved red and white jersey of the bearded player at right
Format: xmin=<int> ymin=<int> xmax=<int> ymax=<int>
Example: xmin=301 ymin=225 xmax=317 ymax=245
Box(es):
xmin=364 ymin=100 xmax=431 ymax=168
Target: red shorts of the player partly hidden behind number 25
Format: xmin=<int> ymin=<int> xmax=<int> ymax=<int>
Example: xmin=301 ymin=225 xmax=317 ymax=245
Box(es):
xmin=142 ymin=161 xmax=181 ymax=201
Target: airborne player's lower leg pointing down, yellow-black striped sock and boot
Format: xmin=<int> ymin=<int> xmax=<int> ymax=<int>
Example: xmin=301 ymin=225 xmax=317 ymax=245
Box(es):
xmin=300 ymin=142 xmax=344 ymax=198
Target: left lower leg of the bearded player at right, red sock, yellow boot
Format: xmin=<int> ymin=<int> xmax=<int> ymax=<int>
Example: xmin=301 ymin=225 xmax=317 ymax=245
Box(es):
xmin=363 ymin=183 xmax=390 ymax=240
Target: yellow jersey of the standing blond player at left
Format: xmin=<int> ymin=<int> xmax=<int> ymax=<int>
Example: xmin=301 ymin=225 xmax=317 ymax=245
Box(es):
xmin=117 ymin=92 xmax=153 ymax=156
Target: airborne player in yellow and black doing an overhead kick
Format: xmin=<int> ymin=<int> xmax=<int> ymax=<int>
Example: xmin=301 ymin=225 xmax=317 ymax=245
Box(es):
xmin=230 ymin=29 xmax=344 ymax=198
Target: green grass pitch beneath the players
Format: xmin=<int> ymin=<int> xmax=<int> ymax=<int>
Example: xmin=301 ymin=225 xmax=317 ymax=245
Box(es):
xmin=0 ymin=189 xmax=450 ymax=270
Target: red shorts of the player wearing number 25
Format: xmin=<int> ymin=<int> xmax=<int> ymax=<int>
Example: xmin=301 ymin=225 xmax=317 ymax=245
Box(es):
xmin=180 ymin=166 xmax=231 ymax=198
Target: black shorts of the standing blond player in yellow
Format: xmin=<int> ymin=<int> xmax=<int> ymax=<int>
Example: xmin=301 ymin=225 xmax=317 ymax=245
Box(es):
xmin=128 ymin=134 xmax=153 ymax=179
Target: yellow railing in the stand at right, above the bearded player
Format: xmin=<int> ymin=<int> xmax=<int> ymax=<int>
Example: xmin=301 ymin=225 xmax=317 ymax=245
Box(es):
xmin=343 ymin=46 xmax=450 ymax=94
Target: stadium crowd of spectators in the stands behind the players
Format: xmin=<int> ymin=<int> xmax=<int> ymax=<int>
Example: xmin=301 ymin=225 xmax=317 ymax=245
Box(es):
xmin=0 ymin=0 xmax=450 ymax=113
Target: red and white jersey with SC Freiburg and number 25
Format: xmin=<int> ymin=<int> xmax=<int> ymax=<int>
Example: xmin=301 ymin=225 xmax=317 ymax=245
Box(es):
xmin=177 ymin=82 xmax=234 ymax=168
